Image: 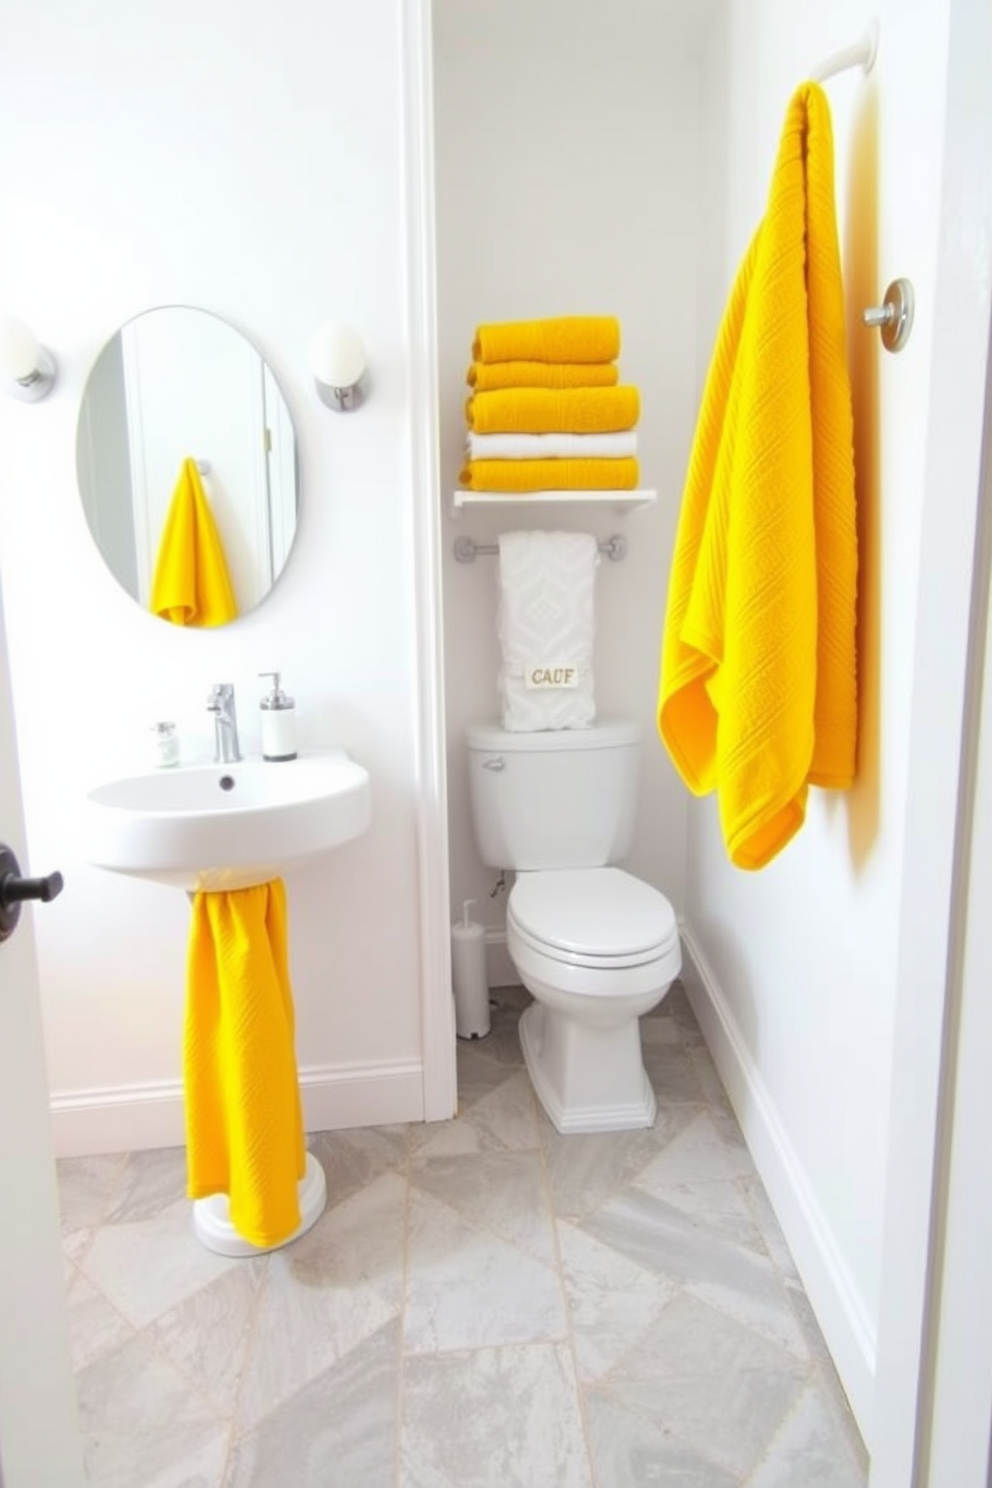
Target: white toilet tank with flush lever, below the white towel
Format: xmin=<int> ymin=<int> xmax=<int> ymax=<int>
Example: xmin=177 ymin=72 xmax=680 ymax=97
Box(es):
xmin=466 ymin=720 xmax=641 ymax=869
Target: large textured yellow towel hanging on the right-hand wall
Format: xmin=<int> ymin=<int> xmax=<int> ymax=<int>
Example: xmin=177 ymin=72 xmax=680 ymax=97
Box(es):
xmin=659 ymin=83 xmax=857 ymax=869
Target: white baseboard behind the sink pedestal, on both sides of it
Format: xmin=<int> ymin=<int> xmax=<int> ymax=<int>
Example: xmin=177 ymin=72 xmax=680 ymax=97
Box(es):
xmin=51 ymin=1059 xmax=424 ymax=1158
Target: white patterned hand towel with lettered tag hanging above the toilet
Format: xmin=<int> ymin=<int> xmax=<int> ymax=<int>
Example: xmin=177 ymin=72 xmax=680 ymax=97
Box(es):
xmin=498 ymin=533 xmax=599 ymax=734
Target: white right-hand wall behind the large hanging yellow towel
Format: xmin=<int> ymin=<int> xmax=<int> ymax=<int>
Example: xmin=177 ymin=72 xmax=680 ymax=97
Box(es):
xmin=686 ymin=0 xmax=951 ymax=1436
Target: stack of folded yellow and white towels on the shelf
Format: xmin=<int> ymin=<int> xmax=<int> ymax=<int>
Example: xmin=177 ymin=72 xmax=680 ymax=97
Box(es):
xmin=460 ymin=315 xmax=641 ymax=494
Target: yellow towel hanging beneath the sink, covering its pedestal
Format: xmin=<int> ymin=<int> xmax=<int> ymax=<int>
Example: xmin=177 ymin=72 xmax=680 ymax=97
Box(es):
xmin=183 ymin=878 xmax=306 ymax=1245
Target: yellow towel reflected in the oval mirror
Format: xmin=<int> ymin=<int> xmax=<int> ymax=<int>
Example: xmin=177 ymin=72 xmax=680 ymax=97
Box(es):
xmin=149 ymin=460 xmax=238 ymax=625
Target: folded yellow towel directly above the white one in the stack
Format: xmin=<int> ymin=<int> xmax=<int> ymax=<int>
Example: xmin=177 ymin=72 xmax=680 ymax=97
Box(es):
xmin=466 ymin=387 xmax=641 ymax=434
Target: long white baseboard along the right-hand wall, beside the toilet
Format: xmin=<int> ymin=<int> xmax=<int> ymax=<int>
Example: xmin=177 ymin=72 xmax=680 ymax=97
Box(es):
xmin=680 ymin=924 xmax=876 ymax=1442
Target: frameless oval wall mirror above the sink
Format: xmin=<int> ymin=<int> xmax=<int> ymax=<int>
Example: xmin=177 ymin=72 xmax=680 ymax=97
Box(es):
xmin=76 ymin=305 xmax=299 ymax=625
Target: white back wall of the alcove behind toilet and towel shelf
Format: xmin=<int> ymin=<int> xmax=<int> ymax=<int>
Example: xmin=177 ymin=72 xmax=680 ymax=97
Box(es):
xmin=434 ymin=0 xmax=709 ymax=946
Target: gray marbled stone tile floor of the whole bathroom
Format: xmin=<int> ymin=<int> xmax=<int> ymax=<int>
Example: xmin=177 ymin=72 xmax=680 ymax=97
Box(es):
xmin=59 ymin=985 xmax=867 ymax=1488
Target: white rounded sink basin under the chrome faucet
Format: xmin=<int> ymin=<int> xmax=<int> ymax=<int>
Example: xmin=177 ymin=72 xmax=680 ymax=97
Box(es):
xmin=82 ymin=750 xmax=370 ymax=893
